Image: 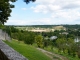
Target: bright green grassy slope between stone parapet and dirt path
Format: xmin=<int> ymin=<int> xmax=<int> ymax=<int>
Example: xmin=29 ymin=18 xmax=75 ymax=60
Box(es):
xmin=5 ymin=40 xmax=51 ymax=60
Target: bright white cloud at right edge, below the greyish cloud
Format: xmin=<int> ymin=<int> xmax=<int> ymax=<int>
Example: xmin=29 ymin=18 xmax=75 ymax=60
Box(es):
xmin=51 ymin=10 xmax=80 ymax=19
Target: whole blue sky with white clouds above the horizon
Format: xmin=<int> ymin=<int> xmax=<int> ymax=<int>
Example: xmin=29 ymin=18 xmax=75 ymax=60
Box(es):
xmin=5 ymin=0 xmax=80 ymax=25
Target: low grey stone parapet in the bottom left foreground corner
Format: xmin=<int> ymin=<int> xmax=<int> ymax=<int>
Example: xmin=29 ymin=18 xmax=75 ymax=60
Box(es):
xmin=0 ymin=39 xmax=28 ymax=60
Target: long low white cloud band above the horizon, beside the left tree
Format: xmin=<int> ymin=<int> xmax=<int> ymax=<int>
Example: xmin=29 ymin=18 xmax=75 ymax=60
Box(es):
xmin=5 ymin=18 xmax=51 ymax=25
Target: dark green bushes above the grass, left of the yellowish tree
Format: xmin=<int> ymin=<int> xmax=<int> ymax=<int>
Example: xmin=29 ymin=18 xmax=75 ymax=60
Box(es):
xmin=10 ymin=26 xmax=35 ymax=45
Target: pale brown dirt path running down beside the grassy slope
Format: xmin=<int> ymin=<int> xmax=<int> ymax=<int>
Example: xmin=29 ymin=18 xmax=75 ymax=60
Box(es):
xmin=37 ymin=48 xmax=68 ymax=60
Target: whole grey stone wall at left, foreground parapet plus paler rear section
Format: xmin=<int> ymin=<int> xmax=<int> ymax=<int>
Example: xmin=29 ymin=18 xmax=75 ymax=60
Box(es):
xmin=0 ymin=29 xmax=28 ymax=60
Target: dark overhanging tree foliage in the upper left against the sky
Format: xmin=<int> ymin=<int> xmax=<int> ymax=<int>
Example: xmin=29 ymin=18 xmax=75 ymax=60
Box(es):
xmin=0 ymin=0 xmax=35 ymax=24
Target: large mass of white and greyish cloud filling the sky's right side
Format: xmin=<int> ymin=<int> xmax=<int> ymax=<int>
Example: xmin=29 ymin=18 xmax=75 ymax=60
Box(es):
xmin=32 ymin=0 xmax=80 ymax=24
